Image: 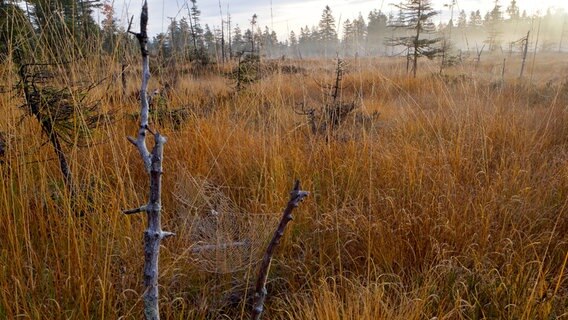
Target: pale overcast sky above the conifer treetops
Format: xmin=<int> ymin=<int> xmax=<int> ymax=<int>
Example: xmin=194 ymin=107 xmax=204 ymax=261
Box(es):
xmin=99 ymin=0 xmax=568 ymax=40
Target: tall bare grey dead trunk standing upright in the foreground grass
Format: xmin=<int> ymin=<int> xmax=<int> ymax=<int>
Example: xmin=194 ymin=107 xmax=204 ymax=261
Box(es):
xmin=124 ymin=1 xmax=174 ymax=320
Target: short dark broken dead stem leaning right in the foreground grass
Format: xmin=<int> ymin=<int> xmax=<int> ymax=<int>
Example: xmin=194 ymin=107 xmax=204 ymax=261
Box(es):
xmin=252 ymin=180 xmax=309 ymax=320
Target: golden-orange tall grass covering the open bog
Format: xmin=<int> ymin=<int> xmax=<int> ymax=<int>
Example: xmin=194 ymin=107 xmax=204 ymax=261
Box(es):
xmin=0 ymin=55 xmax=568 ymax=320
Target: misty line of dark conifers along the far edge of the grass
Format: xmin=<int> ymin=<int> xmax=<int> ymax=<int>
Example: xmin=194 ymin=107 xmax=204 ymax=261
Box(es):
xmin=0 ymin=0 xmax=568 ymax=62
